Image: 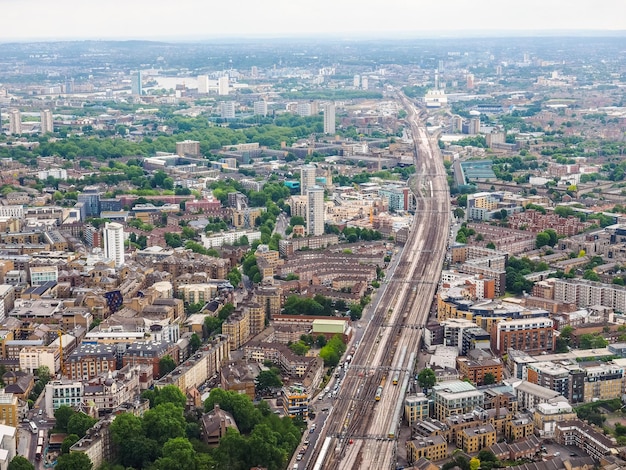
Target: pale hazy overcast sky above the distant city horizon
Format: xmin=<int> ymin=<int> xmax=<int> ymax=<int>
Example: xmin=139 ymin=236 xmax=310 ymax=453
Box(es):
xmin=0 ymin=0 xmax=626 ymax=42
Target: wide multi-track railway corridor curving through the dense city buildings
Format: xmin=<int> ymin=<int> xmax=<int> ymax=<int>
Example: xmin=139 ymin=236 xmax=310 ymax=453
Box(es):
xmin=306 ymin=95 xmax=450 ymax=470
